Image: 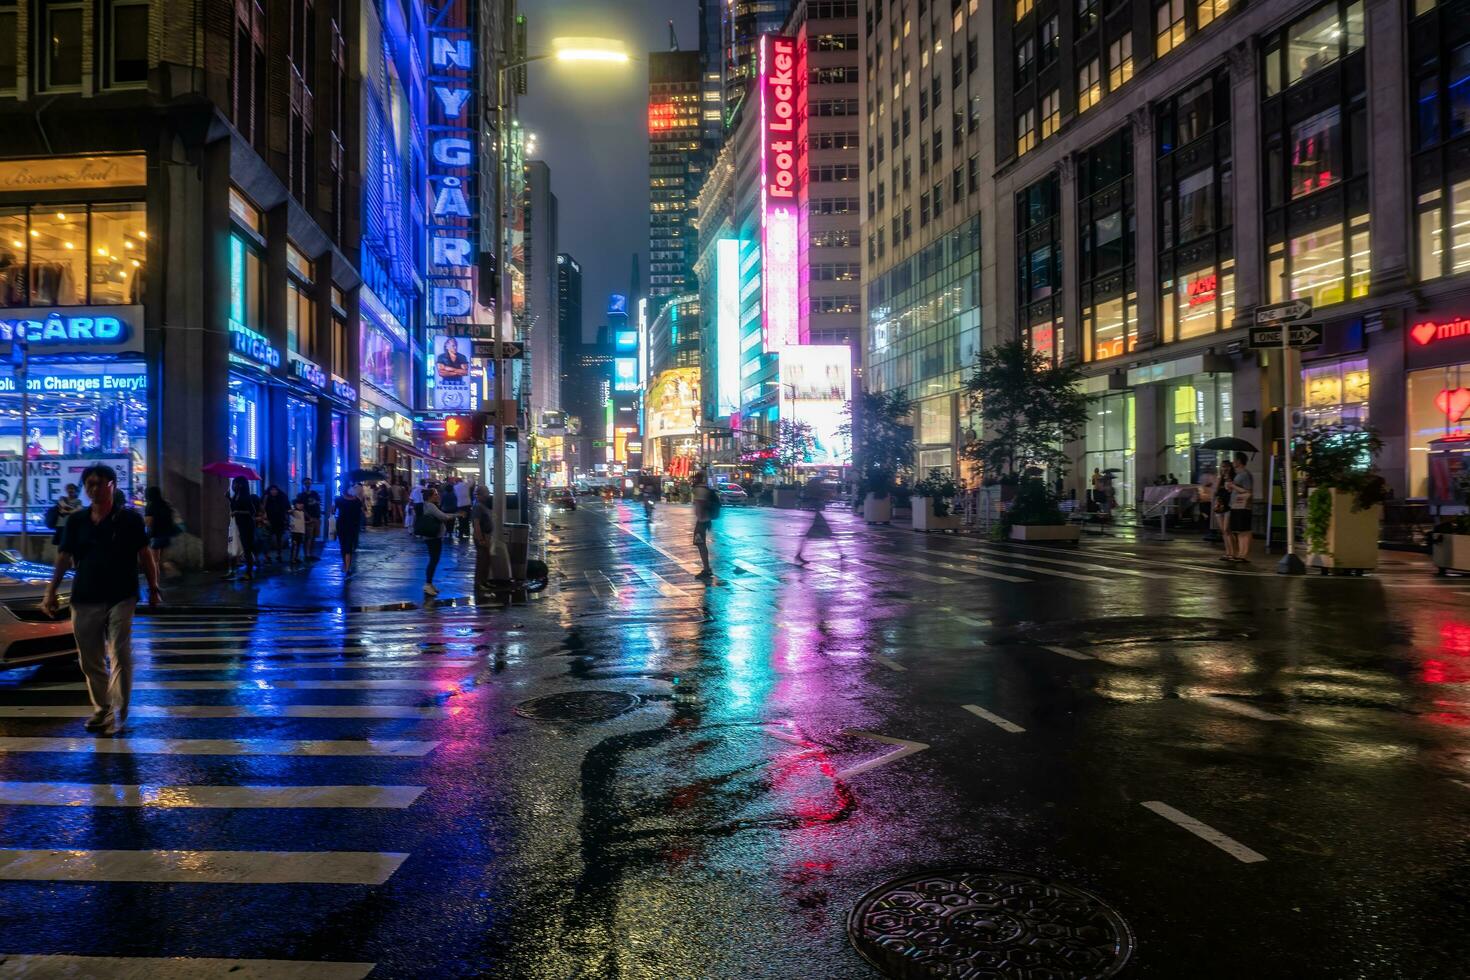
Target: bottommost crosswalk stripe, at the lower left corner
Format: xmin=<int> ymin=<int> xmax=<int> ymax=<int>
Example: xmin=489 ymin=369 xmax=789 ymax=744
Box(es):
xmin=0 ymin=954 xmax=378 ymax=980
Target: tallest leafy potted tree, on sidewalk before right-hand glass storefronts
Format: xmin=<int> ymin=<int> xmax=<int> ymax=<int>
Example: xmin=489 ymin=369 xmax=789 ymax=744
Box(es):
xmin=964 ymin=341 xmax=1088 ymax=542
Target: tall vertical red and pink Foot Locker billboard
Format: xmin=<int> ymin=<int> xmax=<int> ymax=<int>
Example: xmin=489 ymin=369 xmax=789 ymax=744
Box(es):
xmin=759 ymin=34 xmax=806 ymax=353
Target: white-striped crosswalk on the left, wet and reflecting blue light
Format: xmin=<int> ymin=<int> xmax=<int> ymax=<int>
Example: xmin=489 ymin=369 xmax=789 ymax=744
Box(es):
xmin=0 ymin=608 xmax=503 ymax=980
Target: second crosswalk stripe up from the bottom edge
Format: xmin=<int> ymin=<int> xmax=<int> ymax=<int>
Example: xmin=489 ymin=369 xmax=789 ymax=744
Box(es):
xmin=0 ymin=848 xmax=409 ymax=884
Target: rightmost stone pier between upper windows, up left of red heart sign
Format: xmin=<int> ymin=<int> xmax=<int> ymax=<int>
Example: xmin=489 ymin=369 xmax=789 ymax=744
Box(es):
xmin=1366 ymin=0 xmax=1413 ymax=295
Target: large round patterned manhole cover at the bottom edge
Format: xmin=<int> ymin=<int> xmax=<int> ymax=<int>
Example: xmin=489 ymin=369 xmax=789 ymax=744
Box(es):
xmin=847 ymin=868 xmax=1133 ymax=980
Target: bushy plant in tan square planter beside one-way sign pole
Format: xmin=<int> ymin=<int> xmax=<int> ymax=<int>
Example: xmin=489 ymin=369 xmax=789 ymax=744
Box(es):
xmin=1292 ymin=425 xmax=1388 ymax=574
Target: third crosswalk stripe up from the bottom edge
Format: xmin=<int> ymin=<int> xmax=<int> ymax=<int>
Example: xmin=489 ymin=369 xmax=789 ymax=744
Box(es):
xmin=0 ymin=782 xmax=425 ymax=810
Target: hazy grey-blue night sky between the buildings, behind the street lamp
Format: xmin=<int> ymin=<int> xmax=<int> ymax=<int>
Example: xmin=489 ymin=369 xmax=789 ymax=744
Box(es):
xmin=520 ymin=0 xmax=700 ymax=345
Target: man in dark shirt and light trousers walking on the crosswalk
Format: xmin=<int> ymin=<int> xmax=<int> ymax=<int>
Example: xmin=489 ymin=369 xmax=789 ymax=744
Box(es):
xmin=41 ymin=464 xmax=163 ymax=735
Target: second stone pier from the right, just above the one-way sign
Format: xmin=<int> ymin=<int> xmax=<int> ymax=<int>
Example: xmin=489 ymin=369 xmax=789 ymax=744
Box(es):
xmin=1229 ymin=40 xmax=1269 ymax=326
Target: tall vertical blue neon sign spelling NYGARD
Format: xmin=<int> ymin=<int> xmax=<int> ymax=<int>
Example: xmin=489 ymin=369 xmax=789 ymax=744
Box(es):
xmin=428 ymin=0 xmax=479 ymax=325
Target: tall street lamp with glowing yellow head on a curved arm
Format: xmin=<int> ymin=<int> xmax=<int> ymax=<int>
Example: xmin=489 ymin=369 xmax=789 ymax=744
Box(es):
xmin=491 ymin=37 xmax=632 ymax=567
